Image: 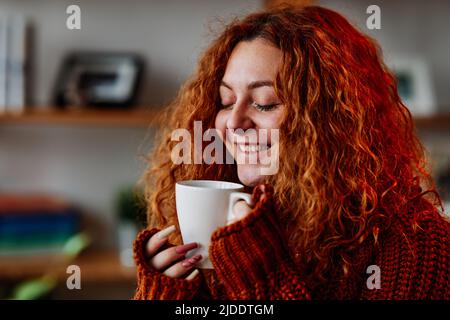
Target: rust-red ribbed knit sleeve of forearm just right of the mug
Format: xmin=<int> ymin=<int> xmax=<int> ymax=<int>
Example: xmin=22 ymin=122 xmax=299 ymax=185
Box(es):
xmin=209 ymin=185 xmax=310 ymax=300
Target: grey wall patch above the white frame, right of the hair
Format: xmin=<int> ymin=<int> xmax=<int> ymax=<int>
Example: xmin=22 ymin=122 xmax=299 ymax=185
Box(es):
xmin=317 ymin=0 xmax=450 ymax=112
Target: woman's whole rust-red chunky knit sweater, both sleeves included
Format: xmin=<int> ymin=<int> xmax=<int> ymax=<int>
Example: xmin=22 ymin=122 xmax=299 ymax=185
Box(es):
xmin=134 ymin=188 xmax=450 ymax=300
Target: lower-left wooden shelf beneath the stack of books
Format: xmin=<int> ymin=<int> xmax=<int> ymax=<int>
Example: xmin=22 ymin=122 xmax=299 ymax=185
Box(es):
xmin=0 ymin=251 xmax=136 ymax=283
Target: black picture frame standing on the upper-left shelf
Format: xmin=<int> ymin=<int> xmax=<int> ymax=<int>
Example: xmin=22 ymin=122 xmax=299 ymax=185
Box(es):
xmin=55 ymin=52 xmax=144 ymax=108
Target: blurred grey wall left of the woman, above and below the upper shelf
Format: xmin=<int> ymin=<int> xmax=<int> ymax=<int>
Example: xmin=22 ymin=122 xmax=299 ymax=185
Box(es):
xmin=0 ymin=0 xmax=260 ymax=247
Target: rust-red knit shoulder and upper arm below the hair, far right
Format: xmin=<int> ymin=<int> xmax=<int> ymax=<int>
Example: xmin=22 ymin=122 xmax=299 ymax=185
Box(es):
xmin=362 ymin=206 xmax=450 ymax=300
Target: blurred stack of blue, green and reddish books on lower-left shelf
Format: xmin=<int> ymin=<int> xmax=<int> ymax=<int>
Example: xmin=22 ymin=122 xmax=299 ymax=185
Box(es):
xmin=0 ymin=194 xmax=80 ymax=256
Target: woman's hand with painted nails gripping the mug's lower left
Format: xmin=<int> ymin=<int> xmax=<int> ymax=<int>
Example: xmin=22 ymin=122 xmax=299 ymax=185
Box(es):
xmin=146 ymin=225 xmax=202 ymax=280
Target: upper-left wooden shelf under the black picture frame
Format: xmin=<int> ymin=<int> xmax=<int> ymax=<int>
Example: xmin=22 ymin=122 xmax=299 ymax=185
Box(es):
xmin=0 ymin=108 xmax=161 ymax=127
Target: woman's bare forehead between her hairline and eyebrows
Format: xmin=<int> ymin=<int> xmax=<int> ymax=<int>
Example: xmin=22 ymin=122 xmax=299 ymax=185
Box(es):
xmin=223 ymin=39 xmax=281 ymax=83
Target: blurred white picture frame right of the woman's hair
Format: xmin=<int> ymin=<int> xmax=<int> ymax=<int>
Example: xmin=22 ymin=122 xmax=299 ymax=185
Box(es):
xmin=388 ymin=56 xmax=437 ymax=116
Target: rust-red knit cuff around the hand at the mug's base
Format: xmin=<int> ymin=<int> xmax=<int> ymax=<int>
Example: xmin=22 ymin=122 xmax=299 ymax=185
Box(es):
xmin=133 ymin=228 xmax=202 ymax=300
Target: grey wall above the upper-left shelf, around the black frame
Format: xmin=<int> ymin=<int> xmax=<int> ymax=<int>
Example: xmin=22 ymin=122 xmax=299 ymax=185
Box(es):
xmin=0 ymin=0 xmax=261 ymax=105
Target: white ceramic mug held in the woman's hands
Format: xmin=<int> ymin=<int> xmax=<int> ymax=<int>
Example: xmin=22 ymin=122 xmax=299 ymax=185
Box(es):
xmin=175 ymin=180 xmax=252 ymax=269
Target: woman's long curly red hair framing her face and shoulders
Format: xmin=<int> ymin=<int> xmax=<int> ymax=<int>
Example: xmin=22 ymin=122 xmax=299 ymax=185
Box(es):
xmin=144 ymin=6 xmax=441 ymax=283
